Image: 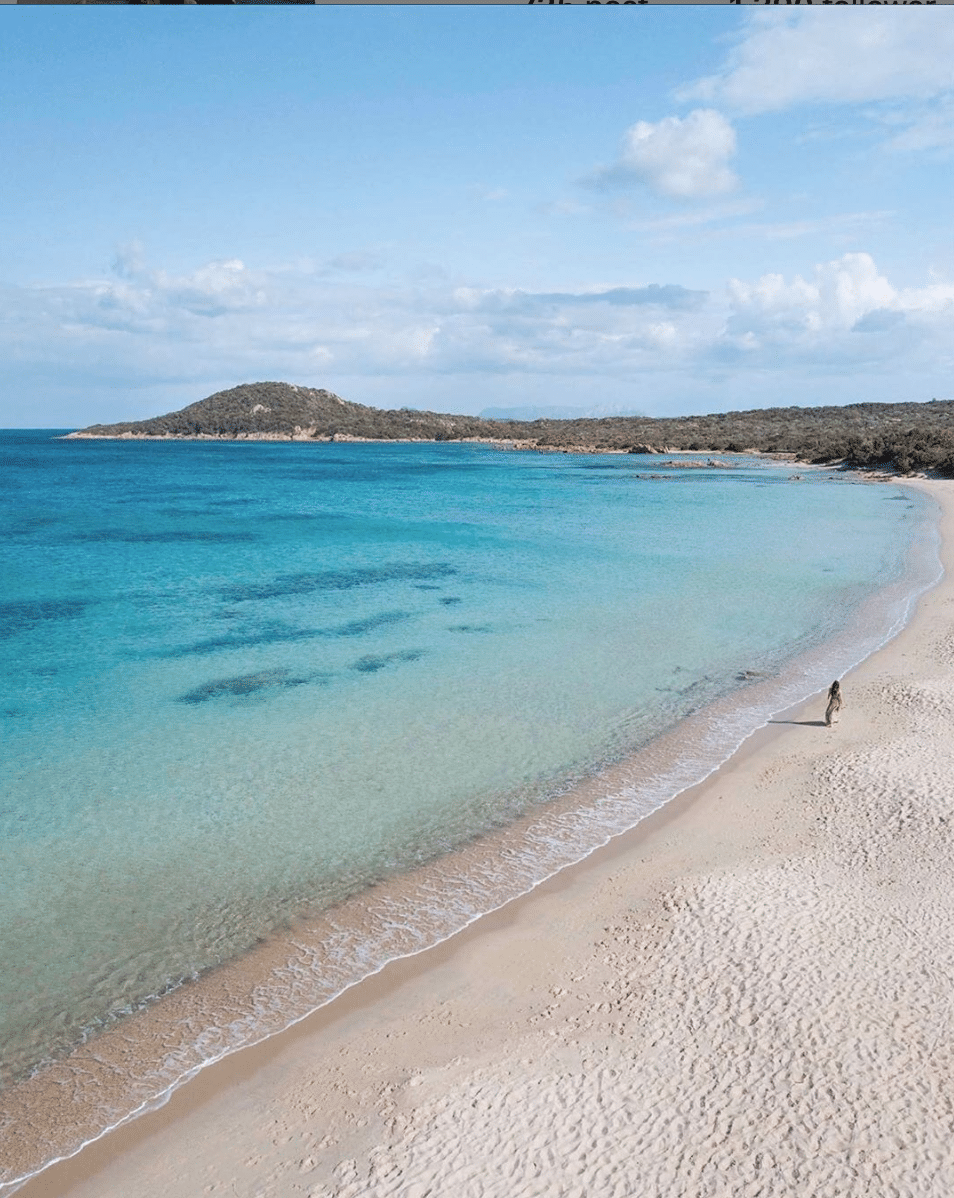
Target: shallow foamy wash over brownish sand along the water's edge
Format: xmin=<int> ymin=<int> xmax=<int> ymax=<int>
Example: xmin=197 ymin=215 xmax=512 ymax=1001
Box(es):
xmin=0 ymin=472 xmax=936 ymax=1194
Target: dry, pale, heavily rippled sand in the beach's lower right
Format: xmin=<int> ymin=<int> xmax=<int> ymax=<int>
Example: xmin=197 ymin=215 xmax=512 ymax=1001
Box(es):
xmin=303 ymin=683 xmax=954 ymax=1198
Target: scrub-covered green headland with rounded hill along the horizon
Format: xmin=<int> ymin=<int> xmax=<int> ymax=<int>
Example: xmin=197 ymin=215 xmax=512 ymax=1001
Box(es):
xmin=73 ymin=382 xmax=954 ymax=477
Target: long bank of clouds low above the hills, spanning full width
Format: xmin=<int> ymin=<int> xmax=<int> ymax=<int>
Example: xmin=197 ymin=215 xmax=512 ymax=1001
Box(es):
xmin=0 ymin=245 xmax=954 ymax=419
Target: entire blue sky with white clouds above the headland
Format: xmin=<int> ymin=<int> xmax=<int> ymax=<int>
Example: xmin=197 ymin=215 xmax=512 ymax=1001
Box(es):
xmin=0 ymin=5 xmax=954 ymax=428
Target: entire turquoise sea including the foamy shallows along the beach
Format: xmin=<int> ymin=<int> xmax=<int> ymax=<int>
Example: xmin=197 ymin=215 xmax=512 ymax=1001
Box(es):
xmin=0 ymin=430 xmax=941 ymax=1193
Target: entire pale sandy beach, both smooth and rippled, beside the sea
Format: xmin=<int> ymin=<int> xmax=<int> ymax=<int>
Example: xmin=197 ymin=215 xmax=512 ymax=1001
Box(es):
xmin=13 ymin=482 xmax=954 ymax=1198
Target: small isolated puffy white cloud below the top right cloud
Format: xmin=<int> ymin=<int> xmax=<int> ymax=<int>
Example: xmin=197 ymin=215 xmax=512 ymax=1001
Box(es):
xmin=590 ymin=108 xmax=738 ymax=199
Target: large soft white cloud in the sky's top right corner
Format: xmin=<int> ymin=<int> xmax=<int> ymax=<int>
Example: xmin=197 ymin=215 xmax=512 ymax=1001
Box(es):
xmin=677 ymin=6 xmax=954 ymax=113
